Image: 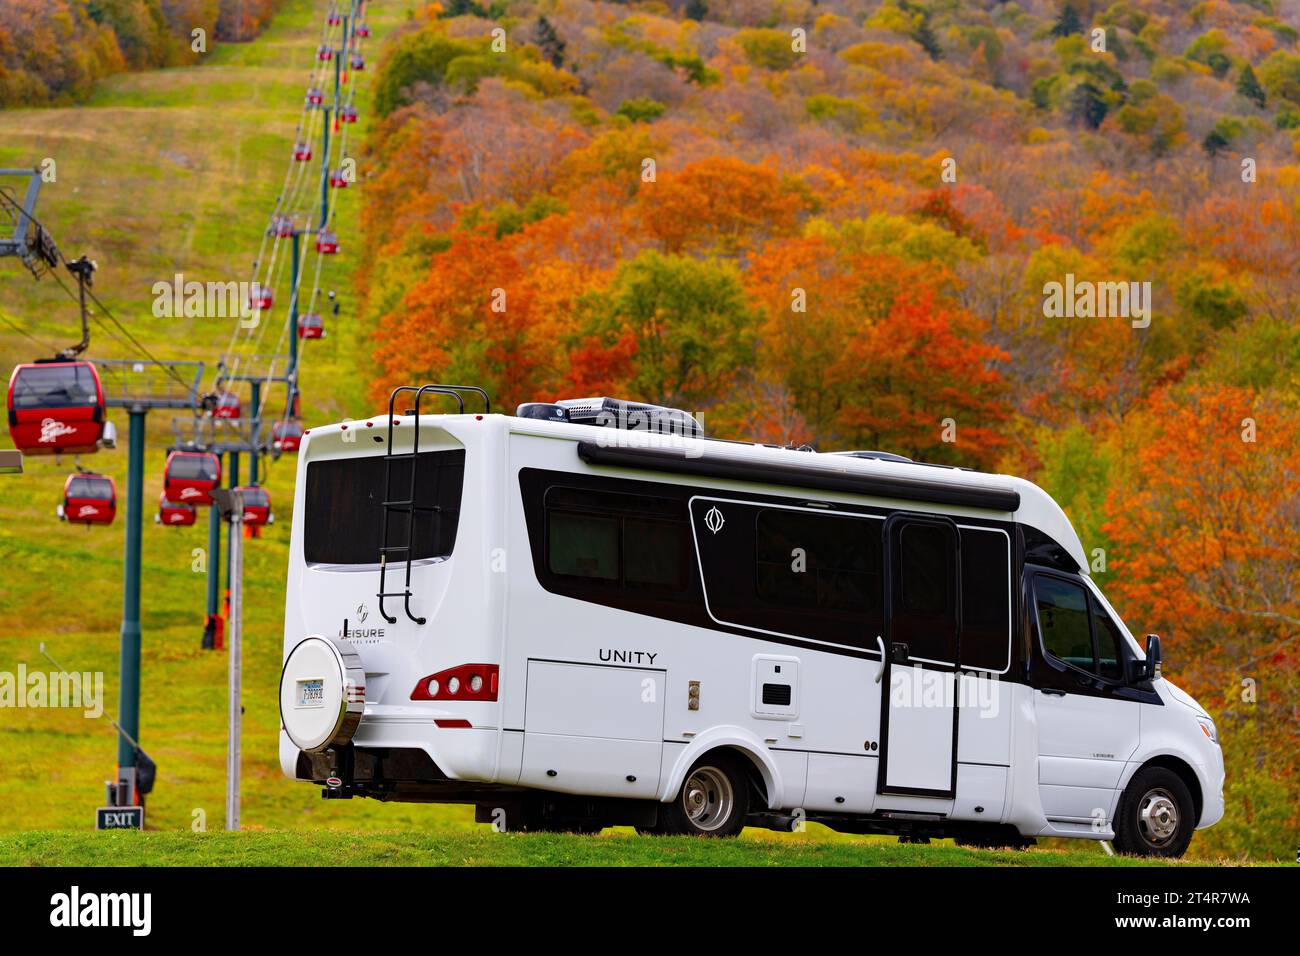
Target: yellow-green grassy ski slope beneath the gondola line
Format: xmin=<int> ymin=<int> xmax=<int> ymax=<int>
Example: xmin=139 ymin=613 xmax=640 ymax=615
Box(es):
xmin=0 ymin=0 xmax=478 ymax=837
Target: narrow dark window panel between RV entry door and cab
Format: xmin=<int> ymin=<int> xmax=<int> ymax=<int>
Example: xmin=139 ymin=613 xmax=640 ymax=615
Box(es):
xmin=961 ymin=528 xmax=1011 ymax=672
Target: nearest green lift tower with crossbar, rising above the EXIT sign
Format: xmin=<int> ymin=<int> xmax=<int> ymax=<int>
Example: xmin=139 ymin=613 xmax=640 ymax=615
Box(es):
xmin=95 ymin=359 xmax=203 ymax=806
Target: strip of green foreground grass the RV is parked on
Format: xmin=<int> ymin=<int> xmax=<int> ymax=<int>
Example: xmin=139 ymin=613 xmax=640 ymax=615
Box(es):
xmin=0 ymin=827 xmax=1216 ymax=866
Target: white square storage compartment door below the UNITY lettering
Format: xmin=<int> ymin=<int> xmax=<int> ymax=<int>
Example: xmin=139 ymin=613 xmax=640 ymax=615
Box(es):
xmin=519 ymin=661 xmax=664 ymax=797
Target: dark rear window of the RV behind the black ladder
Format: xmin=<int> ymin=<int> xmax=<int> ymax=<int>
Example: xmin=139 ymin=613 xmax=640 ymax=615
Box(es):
xmin=303 ymin=449 xmax=465 ymax=564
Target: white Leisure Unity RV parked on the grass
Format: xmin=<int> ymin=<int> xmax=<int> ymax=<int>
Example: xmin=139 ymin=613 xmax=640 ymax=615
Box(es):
xmin=280 ymin=386 xmax=1223 ymax=856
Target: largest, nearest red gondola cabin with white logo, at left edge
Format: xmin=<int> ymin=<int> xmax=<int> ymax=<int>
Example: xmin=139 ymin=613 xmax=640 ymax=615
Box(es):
xmin=9 ymin=362 xmax=104 ymax=455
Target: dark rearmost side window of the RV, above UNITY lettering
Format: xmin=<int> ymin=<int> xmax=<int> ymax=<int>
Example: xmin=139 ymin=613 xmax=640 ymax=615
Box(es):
xmin=546 ymin=488 xmax=690 ymax=592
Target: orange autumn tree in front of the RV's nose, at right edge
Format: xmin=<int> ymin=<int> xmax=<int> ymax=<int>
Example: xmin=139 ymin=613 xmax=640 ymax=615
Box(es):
xmin=1102 ymin=384 xmax=1300 ymax=853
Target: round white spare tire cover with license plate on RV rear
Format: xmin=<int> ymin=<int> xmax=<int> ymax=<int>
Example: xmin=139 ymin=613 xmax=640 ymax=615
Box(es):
xmin=280 ymin=635 xmax=365 ymax=753
